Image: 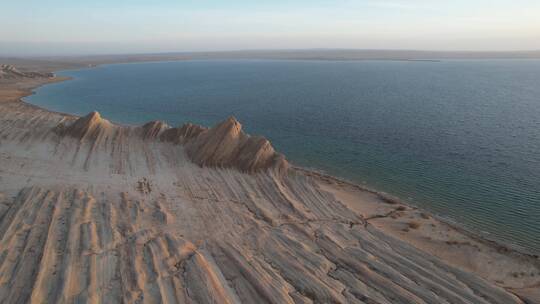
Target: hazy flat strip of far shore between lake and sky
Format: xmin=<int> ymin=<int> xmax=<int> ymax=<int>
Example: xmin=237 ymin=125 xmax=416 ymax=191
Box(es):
xmin=0 ymin=49 xmax=540 ymax=71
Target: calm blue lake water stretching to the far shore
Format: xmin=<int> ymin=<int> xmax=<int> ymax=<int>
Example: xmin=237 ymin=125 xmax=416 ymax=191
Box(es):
xmin=26 ymin=60 xmax=540 ymax=253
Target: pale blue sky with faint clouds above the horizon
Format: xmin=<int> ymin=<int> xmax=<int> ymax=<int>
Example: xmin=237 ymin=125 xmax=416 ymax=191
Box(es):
xmin=0 ymin=0 xmax=540 ymax=56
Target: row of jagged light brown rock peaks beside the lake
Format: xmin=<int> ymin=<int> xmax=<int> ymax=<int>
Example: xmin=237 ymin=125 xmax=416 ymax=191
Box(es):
xmin=57 ymin=112 xmax=288 ymax=173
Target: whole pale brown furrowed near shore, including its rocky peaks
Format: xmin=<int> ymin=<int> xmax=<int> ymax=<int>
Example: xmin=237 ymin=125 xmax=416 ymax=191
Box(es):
xmin=0 ymin=67 xmax=540 ymax=304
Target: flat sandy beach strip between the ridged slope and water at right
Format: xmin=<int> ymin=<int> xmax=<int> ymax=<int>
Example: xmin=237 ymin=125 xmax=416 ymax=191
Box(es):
xmin=319 ymin=178 xmax=540 ymax=303
